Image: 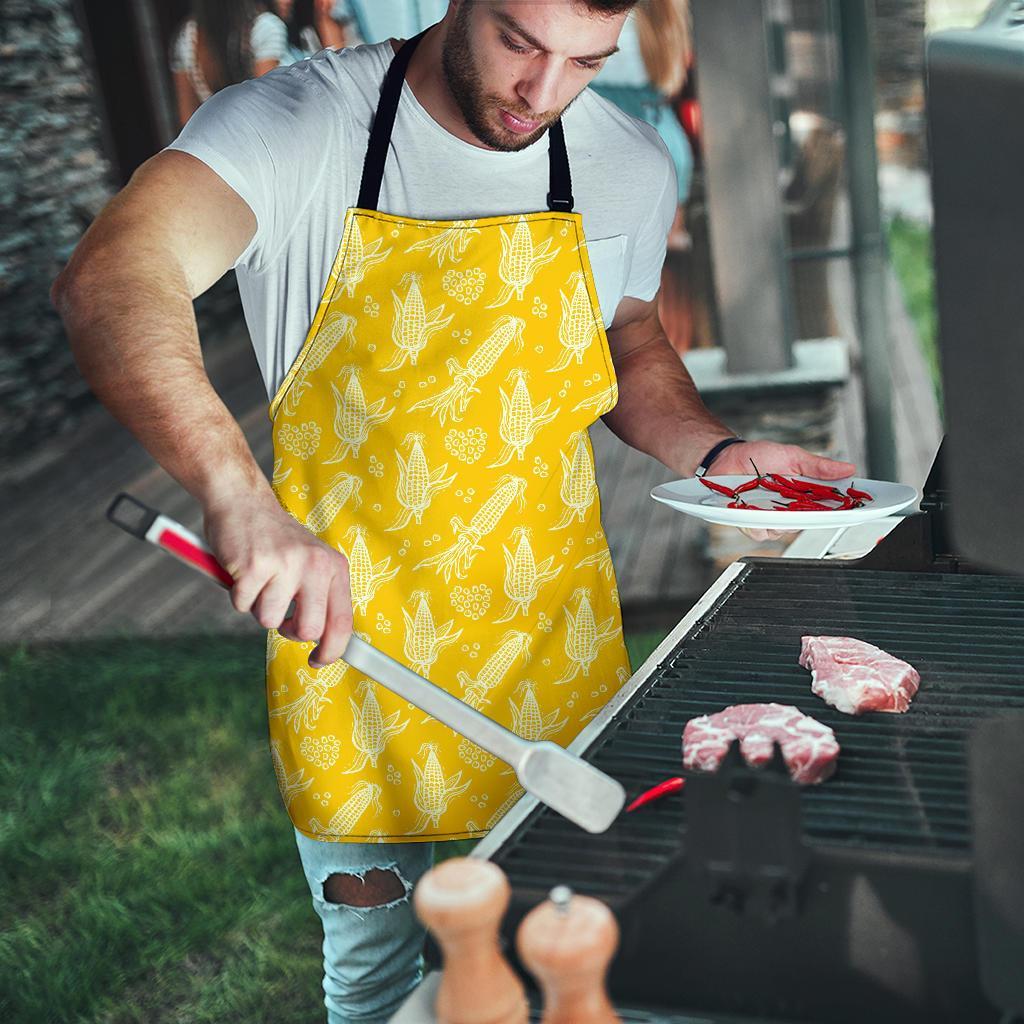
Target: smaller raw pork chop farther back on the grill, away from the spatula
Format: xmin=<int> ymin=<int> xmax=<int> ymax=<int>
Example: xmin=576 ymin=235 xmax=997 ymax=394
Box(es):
xmin=800 ymin=637 xmax=921 ymax=715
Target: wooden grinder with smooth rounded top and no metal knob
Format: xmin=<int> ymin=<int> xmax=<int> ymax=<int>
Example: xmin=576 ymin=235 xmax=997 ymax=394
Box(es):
xmin=413 ymin=857 xmax=529 ymax=1024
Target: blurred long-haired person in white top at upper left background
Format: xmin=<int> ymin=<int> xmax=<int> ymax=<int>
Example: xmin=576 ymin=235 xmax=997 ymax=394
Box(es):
xmin=170 ymin=0 xmax=290 ymax=127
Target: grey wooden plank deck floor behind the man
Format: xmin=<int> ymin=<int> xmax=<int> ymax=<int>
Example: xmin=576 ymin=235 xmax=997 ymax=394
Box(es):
xmin=0 ymin=235 xmax=941 ymax=642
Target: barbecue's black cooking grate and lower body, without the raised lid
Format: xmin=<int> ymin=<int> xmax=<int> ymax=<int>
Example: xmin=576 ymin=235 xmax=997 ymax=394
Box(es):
xmin=479 ymin=448 xmax=1024 ymax=1024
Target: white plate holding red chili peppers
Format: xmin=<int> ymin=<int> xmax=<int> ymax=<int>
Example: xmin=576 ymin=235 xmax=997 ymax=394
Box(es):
xmin=650 ymin=475 xmax=921 ymax=529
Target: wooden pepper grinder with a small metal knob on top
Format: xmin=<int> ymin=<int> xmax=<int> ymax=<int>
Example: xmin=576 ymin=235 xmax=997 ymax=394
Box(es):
xmin=516 ymin=886 xmax=620 ymax=1024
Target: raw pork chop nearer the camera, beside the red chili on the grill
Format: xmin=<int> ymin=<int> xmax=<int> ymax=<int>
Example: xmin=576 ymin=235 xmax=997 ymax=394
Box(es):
xmin=683 ymin=703 xmax=839 ymax=784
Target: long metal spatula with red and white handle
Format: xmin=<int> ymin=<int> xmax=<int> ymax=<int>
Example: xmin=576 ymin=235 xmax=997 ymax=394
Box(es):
xmin=106 ymin=494 xmax=626 ymax=833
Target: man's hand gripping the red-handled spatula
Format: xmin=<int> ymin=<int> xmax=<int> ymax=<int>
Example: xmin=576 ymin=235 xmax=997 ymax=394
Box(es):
xmin=204 ymin=492 xmax=352 ymax=669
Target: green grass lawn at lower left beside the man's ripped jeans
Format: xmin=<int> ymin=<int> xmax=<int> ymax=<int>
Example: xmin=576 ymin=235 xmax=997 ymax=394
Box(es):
xmin=0 ymin=635 xmax=662 ymax=1024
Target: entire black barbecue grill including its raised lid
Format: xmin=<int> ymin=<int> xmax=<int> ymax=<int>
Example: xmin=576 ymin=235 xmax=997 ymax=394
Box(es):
xmin=462 ymin=9 xmax=1024 ymax=1024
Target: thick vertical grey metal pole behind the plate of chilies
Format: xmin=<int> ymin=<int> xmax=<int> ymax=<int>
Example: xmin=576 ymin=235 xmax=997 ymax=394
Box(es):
xmin=835 ymin=0 xmax=899 ymax=480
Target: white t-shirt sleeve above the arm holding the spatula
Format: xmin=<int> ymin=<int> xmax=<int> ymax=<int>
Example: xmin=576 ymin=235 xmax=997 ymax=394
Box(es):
xmin=168 ymin=65 xmax=340 ymax=273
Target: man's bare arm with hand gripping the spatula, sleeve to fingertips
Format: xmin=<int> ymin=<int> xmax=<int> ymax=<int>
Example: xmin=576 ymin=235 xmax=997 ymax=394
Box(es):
xmin=52 ymin=151 xmax=351 ymax=664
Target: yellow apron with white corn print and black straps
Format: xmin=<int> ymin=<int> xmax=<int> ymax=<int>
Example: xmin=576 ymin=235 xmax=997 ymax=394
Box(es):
xmin=266 ymin=37 xmax=630 ymax=843
